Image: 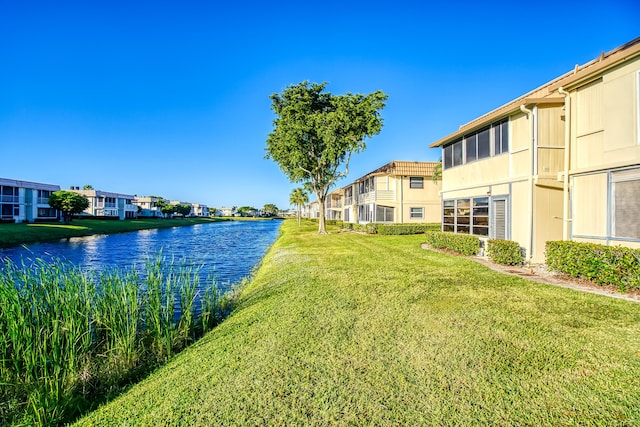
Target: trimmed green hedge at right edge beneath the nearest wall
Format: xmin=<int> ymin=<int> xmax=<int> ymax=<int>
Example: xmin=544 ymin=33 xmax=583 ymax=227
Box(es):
xmin=545 ymin=241 xmax=640 ymax=292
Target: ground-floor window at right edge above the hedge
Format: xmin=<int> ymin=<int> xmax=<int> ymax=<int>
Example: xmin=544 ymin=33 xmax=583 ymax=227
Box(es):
xmin=611 ymin=168 xmax=640 ymax=239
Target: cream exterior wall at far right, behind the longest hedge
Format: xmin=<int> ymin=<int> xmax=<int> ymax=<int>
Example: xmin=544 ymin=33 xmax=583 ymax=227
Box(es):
xmin=569 ymin=57 xmax=640 ymax=247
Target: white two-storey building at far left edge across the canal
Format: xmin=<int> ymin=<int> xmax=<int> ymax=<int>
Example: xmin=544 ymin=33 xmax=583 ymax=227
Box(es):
xmin=0 ymin=178 xmax=60 ymax=222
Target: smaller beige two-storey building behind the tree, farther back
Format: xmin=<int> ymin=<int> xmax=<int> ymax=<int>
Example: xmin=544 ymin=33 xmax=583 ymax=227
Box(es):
xmin=340 ymin=160 xmax=442 ymax=224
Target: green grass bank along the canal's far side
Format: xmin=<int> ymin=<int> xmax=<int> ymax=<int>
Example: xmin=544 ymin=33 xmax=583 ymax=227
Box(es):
xmin=0 ymin=218 xmax=222 ymax=248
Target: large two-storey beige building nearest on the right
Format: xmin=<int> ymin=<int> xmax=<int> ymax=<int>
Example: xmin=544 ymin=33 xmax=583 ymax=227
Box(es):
xmin=431 ymin=38 xmax=640 ymax=262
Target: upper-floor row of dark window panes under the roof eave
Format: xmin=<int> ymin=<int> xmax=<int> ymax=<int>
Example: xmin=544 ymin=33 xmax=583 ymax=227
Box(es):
xmin=442 ymin=119 xmax=509 ymax=169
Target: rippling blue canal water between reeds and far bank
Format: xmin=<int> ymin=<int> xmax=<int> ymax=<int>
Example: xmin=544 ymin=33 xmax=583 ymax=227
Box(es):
xmin=0 ymin=220 xmax=281 ymax=291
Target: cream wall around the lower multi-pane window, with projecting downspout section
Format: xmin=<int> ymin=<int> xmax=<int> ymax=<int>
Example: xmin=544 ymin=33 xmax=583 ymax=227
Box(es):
xmin=442 ymin=108 xmax=564 ymax=262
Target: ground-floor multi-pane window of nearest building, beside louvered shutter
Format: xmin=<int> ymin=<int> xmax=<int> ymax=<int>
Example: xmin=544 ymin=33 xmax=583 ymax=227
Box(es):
xmin=442 ymin=197 xmax=489 ymax=236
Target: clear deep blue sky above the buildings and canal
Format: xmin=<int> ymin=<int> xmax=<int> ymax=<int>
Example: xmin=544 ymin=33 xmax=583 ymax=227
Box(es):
xmin=0 ymin=0 xmax=640 ymax=208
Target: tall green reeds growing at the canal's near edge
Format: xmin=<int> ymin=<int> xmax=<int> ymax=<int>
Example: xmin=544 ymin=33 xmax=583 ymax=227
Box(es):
xmin=0 ymin=254 xmax=228 ymax=426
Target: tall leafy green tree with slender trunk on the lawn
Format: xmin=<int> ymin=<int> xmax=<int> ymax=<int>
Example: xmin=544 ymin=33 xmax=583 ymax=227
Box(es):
xmin=266 ymin=81 xmax=387 ymax=234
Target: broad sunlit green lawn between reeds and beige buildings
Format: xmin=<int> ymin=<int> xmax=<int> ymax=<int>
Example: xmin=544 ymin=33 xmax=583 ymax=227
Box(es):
xmin=80 ymin=221 xmax=640 ymax=425
